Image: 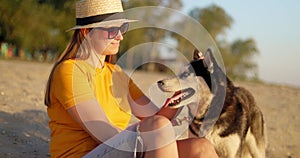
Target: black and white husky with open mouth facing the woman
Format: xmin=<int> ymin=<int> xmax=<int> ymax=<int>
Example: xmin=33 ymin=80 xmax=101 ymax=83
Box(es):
xmin=157 ymin=49 xmax=266 ymax=158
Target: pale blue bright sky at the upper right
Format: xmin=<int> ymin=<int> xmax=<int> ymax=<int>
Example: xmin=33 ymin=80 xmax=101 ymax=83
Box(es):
xmin=183 ymin=0 xmax=300 ymax=87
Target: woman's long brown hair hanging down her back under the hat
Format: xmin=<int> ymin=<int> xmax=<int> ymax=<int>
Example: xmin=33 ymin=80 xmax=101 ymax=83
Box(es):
xmin=44 ymin=29 xmax=114 ymax=106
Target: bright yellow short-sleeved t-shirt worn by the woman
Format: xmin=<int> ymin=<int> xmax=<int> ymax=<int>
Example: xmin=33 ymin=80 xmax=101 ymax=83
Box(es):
xmin=47 ymin=60 xmax=143 ymax=157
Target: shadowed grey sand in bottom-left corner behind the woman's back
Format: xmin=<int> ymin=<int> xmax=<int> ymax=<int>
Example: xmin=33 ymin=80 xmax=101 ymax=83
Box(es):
xmin=0 ymin=110 xmax=50 ymax=158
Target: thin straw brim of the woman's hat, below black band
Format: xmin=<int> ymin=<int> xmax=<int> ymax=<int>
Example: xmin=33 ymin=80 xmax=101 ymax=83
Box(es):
xmin=66 ymin=19 xmax=138 ymax=32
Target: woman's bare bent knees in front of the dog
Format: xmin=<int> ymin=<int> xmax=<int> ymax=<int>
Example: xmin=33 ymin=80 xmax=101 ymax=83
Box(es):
xmin=139 ymin=115 xmax=218 ymax=158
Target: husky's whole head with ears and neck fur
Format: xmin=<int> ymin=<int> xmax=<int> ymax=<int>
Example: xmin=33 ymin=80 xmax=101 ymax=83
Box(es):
xmin=158 ymin=49 xmax=226 ymax=135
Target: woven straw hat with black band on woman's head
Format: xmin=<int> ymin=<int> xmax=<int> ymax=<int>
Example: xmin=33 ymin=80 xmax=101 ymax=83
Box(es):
xmin=67 ymin=0 xmax=136 ymax=31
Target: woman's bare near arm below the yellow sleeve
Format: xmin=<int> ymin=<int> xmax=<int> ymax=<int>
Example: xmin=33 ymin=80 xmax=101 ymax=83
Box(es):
xmin=67 ymin=100 xmax=121 ymax=143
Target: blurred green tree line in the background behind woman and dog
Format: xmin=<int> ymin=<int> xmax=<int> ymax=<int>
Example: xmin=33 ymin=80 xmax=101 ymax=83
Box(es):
xmin=0 ymin=0 xmax=259 ymax=79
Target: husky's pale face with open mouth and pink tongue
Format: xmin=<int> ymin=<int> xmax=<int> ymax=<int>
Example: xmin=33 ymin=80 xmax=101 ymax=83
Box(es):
xmin=157 ymin=48 xmax=213 ymax=117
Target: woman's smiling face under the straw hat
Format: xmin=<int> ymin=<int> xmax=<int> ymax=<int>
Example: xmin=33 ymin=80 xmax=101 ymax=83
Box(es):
xmin=90 ymin=25 xmax=123 ymax=55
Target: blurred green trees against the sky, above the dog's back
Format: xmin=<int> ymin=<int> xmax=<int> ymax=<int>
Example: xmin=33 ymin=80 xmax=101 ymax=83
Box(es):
xmin=186 ymin=4 xmax=258 ymax=79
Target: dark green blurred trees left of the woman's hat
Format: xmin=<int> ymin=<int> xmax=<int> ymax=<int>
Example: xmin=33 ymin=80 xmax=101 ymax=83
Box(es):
xmin=0 ymin=0 xmax=75 ymax=59
